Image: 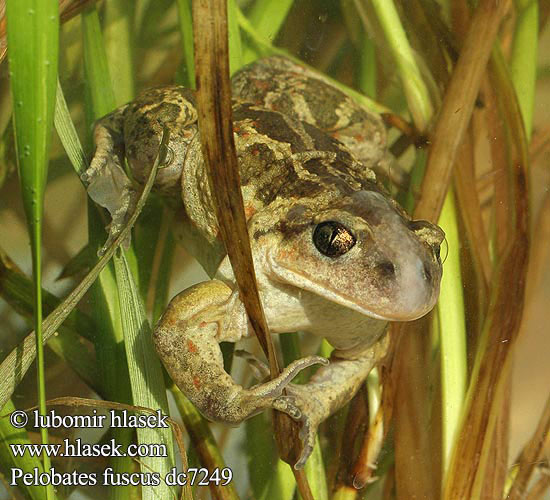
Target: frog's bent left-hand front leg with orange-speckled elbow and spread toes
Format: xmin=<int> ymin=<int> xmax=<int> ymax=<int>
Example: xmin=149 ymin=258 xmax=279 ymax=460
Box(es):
xmin=154 ymin=280 xmax=327 ymax=424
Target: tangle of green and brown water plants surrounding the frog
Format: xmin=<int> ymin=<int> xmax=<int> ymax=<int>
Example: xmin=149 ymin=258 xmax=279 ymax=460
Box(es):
xmin=0 ymin=0 xmax=550 ymax=500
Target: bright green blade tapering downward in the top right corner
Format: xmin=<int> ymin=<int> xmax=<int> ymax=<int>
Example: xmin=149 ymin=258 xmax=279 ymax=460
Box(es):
xmin=510 ymin=0 xmax=539 ymax=140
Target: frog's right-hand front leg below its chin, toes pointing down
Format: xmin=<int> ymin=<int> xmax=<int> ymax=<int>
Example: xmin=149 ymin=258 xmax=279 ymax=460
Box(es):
xmin=287 ymin=336 xmax=389 ymax=469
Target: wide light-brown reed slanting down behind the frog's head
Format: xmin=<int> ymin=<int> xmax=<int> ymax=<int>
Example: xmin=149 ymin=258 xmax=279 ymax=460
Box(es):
xmin=394 ymin=0 xmax=521 ymax=498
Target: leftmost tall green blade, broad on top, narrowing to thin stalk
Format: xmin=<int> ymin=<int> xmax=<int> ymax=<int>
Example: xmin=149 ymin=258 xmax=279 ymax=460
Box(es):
xmin=7 ymin=0 xmax=59 ymax=499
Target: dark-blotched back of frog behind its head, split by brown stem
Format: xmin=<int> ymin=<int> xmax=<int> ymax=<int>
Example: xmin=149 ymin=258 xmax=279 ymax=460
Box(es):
xmin=182 ymin=100 xmax=376 ymax=244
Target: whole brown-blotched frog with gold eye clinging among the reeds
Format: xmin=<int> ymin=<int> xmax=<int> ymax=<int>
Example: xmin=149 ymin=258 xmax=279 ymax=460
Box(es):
xmin=84 ymin=56 xmax=444 ymax=469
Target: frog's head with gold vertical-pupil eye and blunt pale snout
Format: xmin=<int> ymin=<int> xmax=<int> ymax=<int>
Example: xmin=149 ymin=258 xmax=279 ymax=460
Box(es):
xmin=267 ymin=190 xmax=444 ymax=321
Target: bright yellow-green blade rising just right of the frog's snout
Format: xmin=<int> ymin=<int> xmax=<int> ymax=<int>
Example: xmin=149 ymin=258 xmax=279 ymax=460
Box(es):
xmin=437 ymin=191 xmax=468 ymax=472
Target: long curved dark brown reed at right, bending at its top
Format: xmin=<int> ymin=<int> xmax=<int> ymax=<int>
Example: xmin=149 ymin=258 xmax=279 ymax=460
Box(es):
xmin=444 ymin=49 xmax=529 ymax=499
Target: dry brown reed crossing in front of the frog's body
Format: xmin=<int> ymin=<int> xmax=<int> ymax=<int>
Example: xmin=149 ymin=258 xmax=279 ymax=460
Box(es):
xmin=193 ymin=0 xmax=312 ymax=492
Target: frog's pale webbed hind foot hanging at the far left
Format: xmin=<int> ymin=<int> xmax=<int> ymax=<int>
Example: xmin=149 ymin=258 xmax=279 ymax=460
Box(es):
xmin=81 ymin=106 xmax=137 ymax=249
